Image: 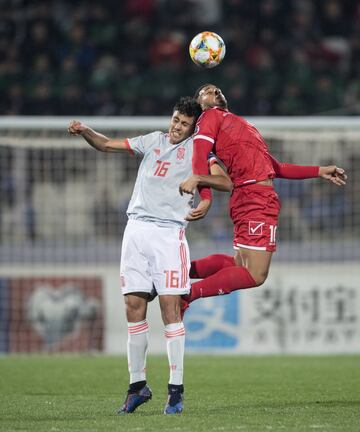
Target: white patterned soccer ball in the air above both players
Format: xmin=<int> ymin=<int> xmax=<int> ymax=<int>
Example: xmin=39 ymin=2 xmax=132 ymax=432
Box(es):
xmin=189 ymin=32 xmax=226 ymax=69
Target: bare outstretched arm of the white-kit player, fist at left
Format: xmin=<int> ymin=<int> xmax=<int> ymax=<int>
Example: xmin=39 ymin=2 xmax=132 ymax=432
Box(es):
xmin=68 ymin=120 xmax=129 ymax=152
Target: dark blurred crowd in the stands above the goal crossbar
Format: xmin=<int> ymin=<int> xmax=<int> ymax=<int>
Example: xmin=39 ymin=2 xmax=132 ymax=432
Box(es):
xmin=0 ymin=0 xmax=360 ymax=116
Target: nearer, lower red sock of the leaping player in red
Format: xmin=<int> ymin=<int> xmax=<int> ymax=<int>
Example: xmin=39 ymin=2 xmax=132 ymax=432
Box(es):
xmin=189 ymin=266 xmax=256 ymax=302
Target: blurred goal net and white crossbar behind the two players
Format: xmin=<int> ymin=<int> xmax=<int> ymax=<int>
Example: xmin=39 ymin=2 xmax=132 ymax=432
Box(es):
xmin=0 ymin=118 xmax=360 ymax=265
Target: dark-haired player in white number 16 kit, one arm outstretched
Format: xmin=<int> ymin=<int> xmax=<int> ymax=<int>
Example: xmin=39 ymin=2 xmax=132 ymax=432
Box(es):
xmin=68 ymin=97 xmax=232 ymax=414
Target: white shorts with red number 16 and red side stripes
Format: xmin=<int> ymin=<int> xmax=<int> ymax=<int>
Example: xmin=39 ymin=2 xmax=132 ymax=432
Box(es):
xmin=120 ymin=219 xmax=190 ymax=295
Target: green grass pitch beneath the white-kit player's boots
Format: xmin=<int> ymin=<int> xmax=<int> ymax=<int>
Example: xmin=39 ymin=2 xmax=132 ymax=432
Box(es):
xmin=0 ymin=355 xmax=360 ymax=432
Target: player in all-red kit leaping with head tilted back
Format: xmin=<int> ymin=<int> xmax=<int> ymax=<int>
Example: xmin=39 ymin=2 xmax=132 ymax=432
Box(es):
xmin=180 ymin=84 xmax=346 ymax=308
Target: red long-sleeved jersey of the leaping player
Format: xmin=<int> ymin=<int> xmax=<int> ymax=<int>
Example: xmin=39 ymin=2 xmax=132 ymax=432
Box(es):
xmin=193 ymin=107 xmax=319 ymax=199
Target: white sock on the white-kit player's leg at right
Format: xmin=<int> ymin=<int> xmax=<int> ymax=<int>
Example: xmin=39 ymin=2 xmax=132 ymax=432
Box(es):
xmin=165 ymin=322 xmax=185 ymax=385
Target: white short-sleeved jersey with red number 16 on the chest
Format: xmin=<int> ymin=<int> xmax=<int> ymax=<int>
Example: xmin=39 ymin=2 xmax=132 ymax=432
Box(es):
xmin=127 ymin=131 xmax=193 ymax=227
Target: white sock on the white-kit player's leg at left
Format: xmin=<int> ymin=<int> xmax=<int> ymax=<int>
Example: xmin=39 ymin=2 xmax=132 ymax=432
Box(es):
xmin=127 ymin=320 xmax=149 ymax=384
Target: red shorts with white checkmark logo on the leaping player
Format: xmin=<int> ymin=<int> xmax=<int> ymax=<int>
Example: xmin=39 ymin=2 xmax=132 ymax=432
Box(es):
xmin=230 ymin=184 xmax=280 ymax=252
